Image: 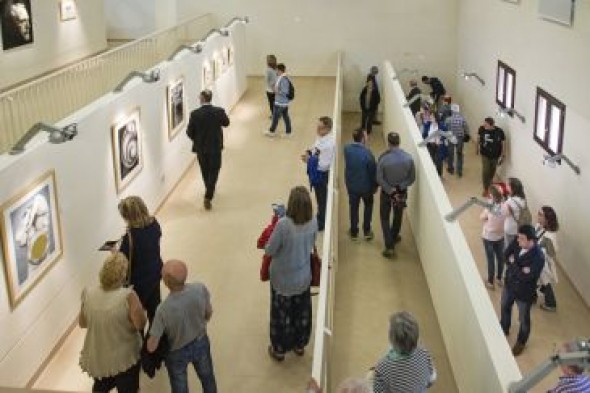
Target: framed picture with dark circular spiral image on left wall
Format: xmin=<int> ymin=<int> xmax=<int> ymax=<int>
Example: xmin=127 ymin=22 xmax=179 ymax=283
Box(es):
xmin=112 ymin=108 xmax=143 ymax=193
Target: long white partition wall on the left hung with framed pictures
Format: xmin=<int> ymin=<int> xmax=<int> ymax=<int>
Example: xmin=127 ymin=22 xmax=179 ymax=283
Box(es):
xmin=0 ymin=24 xmax=247 ymax=387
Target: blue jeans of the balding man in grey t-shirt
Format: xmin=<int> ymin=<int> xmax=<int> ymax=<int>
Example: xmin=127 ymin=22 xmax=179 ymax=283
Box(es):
xmin=166 ymin=334 xmax=217 ymax=393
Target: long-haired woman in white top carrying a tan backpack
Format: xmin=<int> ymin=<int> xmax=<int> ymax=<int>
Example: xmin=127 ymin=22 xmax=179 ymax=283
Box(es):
xmin=502 ymin=177 xmax=532 ymax=248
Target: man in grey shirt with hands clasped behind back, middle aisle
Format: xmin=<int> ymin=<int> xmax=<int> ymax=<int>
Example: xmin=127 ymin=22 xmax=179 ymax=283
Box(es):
xmin=377 ymin=132 xmax=416 ymax=259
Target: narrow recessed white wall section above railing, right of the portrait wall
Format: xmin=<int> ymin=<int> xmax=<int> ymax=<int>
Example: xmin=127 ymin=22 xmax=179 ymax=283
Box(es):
xmin=104 ymin=0 xmax=178 ymax=40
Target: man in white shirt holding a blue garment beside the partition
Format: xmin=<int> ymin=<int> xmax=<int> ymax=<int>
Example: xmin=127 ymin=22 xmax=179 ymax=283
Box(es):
xmin=301 ymin=116 xmax=336 ymax=232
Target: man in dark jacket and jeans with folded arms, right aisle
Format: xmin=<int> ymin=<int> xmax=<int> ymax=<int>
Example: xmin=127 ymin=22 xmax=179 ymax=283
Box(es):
xmin=500 ymin=225 xmax=545 ymax=356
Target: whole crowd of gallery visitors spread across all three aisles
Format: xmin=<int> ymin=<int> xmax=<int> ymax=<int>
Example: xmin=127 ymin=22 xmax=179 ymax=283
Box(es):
xmin=74 ymin=59 xmax=590 ymax=393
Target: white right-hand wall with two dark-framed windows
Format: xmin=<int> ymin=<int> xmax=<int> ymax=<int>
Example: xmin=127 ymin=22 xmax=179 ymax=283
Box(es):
xmin=457 ymin=0 xmax=590 ymax=304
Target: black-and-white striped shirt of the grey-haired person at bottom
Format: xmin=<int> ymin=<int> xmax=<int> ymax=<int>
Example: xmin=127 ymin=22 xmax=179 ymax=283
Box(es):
xmin=373 ymin=347 xmax=436 ymax=393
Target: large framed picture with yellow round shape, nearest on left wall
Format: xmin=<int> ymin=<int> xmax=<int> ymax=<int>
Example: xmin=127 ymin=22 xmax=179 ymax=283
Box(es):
xmin=0 ymin=171 xmax=62 ymax=308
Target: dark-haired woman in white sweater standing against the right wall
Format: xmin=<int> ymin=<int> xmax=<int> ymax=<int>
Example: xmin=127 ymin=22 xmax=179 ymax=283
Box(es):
xmin=535 ymin=206 xmax=559 ymax=311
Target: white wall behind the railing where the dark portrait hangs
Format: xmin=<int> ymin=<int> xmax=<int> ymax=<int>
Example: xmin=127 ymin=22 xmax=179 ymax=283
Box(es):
xmin=0 ymin=0 xmax=107 ymax=89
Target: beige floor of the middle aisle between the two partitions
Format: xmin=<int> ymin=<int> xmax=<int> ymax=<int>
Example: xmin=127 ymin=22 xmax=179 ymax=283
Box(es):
xmin=332 ymin=113 xmax=457 ymax=393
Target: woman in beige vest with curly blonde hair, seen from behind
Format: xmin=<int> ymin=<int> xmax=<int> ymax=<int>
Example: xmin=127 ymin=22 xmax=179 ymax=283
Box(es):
xmin=78 ymin=252 xmax=147 ymax=393
